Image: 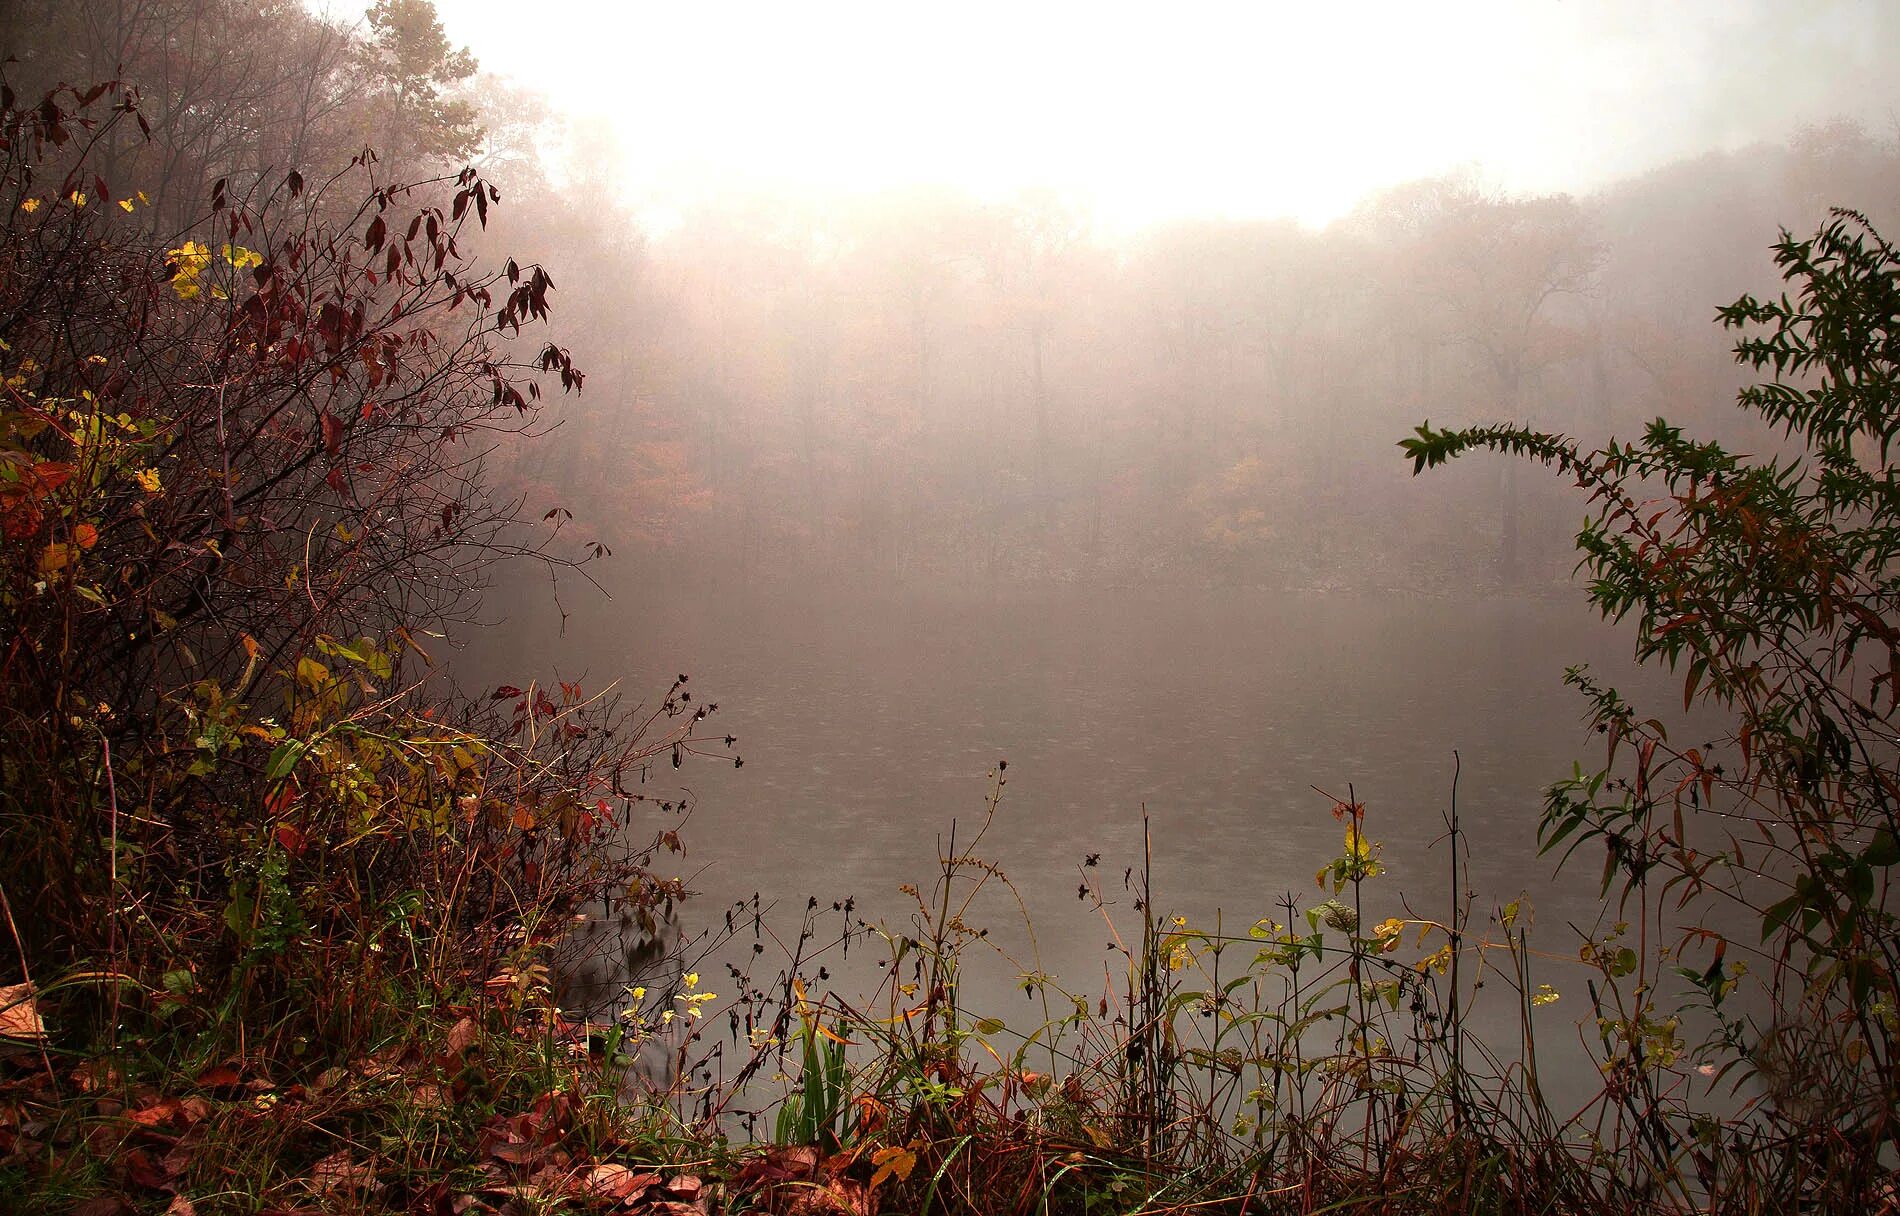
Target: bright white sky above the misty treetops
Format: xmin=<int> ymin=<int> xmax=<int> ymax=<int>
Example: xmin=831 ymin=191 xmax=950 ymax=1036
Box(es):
xmin=423 ymin=0 xmax=1900 ymax=228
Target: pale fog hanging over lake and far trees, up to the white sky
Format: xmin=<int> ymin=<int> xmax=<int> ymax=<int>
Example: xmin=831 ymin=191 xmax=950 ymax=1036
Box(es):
xmin=6 ymin=0 xmax=1900 ymax=1109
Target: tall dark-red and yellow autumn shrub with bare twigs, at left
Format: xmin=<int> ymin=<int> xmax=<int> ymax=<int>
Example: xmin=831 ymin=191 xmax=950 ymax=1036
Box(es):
xmin=0 ymin=86 xmax=705 ymax=1051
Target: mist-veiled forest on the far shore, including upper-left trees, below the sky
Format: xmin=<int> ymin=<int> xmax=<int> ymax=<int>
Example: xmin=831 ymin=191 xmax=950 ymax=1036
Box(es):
xmin=14 ymin=0 xmax=1900 ymax=604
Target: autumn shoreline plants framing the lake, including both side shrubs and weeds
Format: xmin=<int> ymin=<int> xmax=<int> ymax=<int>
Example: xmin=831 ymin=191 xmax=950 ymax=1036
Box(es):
xmin=0 ymin=84 xmax=1900 ymax=1216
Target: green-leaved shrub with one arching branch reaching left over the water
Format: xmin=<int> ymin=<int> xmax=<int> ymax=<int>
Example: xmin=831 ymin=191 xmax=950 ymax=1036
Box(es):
xmin=1402 ymin=211 xmax=1900 ymax=1210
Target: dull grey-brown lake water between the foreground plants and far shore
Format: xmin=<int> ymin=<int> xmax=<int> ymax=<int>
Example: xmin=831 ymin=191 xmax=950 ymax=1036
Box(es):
xmin=462 ymin=580 xmax=1710 ymax=1094
